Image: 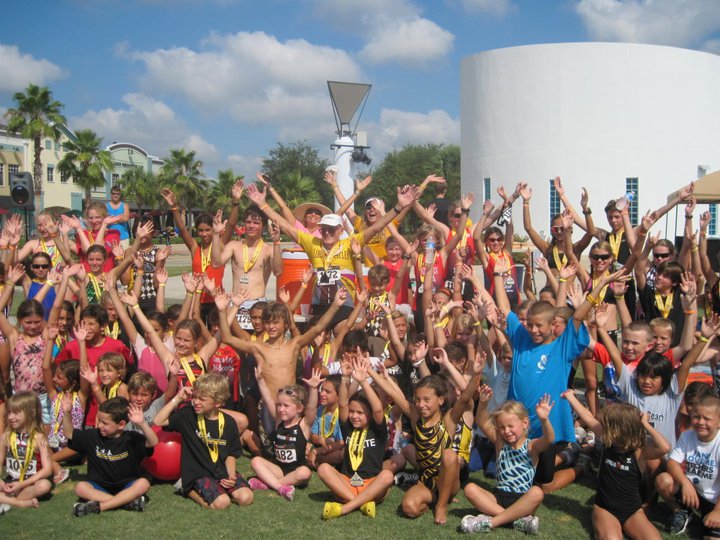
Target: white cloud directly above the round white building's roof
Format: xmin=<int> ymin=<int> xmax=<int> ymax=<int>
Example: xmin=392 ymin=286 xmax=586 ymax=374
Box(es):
xmin=575 ymin=0 xmax=720 ymax=47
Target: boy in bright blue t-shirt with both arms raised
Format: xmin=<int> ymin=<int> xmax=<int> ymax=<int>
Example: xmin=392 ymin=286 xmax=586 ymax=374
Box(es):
xmin=494 ymin=259 xmax=604 ymax=493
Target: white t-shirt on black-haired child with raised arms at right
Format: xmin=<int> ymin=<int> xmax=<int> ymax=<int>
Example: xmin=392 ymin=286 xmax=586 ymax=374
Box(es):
xmin=618 ymin=366 xmax=683 ymax=447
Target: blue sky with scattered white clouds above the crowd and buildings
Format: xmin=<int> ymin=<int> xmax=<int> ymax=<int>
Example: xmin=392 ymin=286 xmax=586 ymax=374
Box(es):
xmin=0 ymin=0 xmax=720 ymax=177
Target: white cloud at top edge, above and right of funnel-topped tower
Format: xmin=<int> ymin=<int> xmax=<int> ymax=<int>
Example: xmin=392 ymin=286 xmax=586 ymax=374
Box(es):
xmin=313 ymin=0 xmax=455 ymax=68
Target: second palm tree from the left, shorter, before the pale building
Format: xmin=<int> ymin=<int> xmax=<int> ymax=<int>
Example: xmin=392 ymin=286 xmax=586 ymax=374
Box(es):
xmin=58 ymin=129 xmax=115 ymax=206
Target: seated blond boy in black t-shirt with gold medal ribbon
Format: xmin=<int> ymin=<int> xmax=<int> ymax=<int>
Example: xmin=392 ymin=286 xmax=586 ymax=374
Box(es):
xmin=155 ymin=373 xmax=253 ymax=510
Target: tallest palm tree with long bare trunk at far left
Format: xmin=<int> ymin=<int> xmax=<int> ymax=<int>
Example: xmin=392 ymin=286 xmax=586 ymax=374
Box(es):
xmin=5 ymin=83 xmax=66 ymax=210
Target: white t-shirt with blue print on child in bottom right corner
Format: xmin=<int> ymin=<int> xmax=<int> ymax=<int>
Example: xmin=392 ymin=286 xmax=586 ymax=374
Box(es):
xmin=669 ymin=429 xmax=720 ymax=503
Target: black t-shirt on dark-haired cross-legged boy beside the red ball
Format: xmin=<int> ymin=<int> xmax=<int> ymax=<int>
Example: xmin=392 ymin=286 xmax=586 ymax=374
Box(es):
xmin=68 ymin=429 xmax=153 ymax=491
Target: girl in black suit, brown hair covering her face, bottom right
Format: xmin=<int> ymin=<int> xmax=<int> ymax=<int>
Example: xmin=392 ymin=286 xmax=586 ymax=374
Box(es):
xmin=562 ymin=390 xmax=670 ymax=540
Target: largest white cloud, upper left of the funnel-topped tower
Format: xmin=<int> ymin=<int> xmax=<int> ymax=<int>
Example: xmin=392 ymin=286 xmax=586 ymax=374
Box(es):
xmin=129 ymin=32 xmax=364 ymax=124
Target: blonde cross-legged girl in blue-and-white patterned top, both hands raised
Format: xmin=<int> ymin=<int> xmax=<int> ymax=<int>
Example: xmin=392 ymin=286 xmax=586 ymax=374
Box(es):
xmin=460 ymin=385 xmax=555 ymax=534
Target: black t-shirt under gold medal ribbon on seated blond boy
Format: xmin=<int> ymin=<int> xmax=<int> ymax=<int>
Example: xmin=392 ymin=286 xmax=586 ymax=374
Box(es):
xmin=163 ymin=407 xmax=241 ymax=493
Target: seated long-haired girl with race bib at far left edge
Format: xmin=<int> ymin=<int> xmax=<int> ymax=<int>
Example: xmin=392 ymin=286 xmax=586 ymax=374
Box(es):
xmin=0 ymin=391 xmax=52 ymax=514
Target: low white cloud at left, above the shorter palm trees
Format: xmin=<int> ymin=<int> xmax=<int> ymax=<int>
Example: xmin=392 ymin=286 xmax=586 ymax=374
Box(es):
xmin=70 ymin=93 xmax=218 ymax=166
